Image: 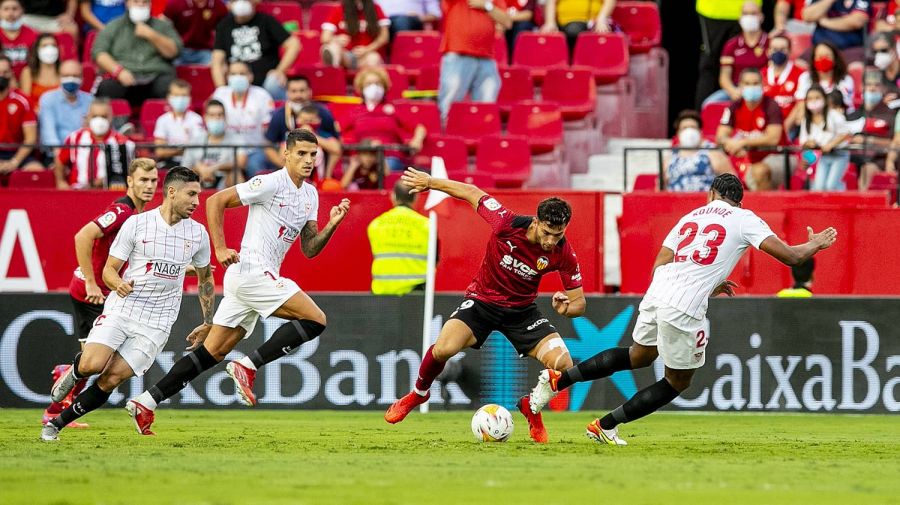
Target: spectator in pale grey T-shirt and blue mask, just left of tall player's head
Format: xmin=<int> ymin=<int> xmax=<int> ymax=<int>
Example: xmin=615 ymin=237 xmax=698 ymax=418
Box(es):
xmin=181 ymin=100 xmax=247 ymax=188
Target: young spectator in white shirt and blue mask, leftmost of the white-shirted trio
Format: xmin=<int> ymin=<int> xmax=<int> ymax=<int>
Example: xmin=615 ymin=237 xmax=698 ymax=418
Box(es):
xmin=153 ymin=79 xmax=203 ymax=168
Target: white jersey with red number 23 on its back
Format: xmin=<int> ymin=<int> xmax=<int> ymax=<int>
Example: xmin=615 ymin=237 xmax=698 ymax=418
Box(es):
xmin=647 ymin=200 xmax=774 ymax=319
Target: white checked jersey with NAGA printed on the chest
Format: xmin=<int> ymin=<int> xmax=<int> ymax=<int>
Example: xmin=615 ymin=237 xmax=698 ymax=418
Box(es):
xmin=103 ymin=208 xmax=210 ymax=332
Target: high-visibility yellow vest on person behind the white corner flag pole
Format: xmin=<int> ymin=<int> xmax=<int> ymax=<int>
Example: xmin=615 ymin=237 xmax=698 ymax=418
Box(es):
xmin=367 ymin=205 xmax=428 ymax=296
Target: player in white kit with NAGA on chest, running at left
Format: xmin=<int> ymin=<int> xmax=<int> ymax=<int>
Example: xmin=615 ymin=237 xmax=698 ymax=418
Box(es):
xmin=41 ymin=167 xmax=215 ymax=441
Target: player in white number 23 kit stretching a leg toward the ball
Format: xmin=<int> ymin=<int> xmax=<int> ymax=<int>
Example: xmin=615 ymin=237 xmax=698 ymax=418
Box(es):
xmin=530 ymin=174 xmax=837 ymax=445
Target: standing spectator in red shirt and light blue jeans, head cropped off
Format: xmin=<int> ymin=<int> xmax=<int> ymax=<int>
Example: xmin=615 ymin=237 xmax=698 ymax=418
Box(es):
xmin=438 ymin=0 xmax=512 ymax=121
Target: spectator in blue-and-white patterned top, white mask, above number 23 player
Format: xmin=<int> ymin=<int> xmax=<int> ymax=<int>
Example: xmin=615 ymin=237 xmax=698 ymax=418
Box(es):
xmin=664 ymin=110 xmax=734 ymax=192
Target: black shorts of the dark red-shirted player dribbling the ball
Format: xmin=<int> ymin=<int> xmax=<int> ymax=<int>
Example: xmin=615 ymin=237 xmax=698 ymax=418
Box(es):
xmin=450 ymin=298 xmax=556 ymax=356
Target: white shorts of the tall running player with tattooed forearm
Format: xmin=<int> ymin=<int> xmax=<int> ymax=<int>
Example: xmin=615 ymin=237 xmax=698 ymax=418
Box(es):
xmin=213 ymin=269 xmax=300 ymax=338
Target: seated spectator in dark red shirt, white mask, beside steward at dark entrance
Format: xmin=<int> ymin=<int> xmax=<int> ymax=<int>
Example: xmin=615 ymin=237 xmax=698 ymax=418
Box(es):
xmin=703 ymin=1 xmax=769 ymax=105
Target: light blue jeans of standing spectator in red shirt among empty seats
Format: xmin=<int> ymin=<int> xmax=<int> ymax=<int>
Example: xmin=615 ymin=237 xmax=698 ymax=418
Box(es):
xmin=438 ymin=53 xmax=500 ymax=121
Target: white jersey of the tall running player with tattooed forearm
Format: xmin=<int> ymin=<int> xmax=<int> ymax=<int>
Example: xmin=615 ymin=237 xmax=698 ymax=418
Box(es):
xmin=228 ymin=168 xmax=319 ymax=277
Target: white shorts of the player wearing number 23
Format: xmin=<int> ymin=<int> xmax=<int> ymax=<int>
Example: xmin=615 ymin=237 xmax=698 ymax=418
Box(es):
xmin=632 ymin=297 xmax=709 ymax=370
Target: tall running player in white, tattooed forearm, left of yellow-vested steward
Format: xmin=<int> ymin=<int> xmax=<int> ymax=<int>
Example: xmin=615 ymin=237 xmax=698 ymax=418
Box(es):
xmin=128 ymin=129 xmax=350 ymax=434
